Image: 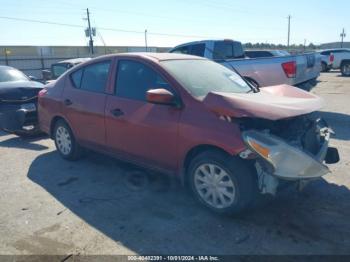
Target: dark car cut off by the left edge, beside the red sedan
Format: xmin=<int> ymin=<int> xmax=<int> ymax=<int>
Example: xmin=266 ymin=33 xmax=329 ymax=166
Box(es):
xmin=0 ymin=66 xmax=44 ymax=135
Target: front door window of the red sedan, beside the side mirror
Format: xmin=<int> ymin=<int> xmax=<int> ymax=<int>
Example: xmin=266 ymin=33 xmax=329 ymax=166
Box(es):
xmin=115 ymin=60 xmax=171 ymax=101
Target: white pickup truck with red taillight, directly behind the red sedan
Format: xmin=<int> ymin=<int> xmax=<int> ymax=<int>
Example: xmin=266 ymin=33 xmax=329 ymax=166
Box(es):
xmin=169 ymin=40 xmax=321 ymax=87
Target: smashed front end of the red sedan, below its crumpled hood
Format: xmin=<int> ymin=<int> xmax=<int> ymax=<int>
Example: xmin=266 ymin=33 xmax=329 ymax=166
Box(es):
xmin=234 ymin=113 xmax=339 ymax=194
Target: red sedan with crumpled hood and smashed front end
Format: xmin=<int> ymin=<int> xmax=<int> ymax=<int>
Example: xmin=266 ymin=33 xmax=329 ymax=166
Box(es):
xmin=38 ymin=53 xmax=339 ymax=213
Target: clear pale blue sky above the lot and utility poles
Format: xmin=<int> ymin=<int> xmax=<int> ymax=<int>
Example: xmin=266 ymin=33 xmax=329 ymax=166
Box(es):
xmin=0 ymin=0 xmax=350 ymax=46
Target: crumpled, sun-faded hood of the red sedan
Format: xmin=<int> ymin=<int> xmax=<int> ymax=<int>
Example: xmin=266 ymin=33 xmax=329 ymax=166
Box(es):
xmin=203 ymin=85 xmax=323 ymax=120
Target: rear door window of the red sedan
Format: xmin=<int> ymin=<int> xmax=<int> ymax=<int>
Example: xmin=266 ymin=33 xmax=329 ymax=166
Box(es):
xmin=71 ymin=61 xmax=111 ymax=93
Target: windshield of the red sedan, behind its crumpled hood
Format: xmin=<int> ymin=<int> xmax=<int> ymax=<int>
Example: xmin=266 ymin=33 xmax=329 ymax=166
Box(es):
xmin=161 ymin=60 xmax=252 ymax=99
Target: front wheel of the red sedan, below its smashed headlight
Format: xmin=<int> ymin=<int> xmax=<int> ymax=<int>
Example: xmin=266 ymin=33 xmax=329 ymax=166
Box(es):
xmin=187 ymin=151 xmax=259 ymax=215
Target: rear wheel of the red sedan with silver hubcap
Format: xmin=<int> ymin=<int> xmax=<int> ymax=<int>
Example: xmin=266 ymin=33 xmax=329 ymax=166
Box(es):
xmin=53 ymin=120 xmax=82 ymax=161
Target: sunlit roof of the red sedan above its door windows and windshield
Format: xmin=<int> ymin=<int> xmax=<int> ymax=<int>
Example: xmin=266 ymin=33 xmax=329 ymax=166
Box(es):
xmin=93 ymin=52 xmax=205 ymax=62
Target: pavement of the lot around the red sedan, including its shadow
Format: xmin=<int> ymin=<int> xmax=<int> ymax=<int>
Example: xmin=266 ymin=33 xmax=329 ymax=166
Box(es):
xmin=0 ymin=72 xmax=350 ymax=255
